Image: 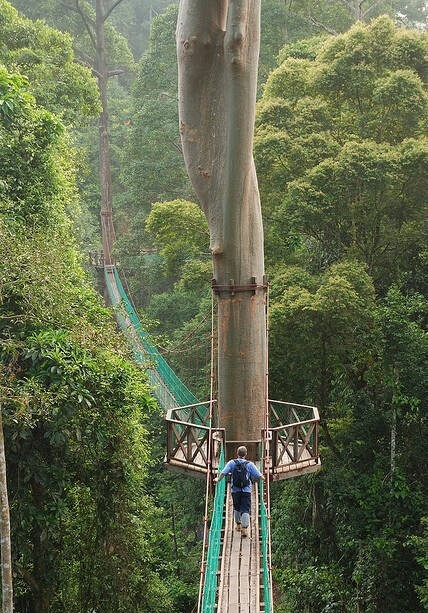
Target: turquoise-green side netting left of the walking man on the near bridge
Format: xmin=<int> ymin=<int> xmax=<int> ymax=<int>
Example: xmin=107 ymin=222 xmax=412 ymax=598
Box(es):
xmin=201 ymin=446 xmax=226 ymax=613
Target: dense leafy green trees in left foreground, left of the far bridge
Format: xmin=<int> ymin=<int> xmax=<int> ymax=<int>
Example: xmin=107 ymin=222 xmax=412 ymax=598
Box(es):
xmin=0 ymin=52 xmax=188 ymax=613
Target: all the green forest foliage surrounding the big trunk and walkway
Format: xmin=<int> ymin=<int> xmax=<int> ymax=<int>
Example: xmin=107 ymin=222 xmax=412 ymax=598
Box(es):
xmin=0 ymin=0 xmax=428 ymax=613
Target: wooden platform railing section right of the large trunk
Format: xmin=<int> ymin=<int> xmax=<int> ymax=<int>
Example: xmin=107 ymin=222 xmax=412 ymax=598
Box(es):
xmin=268 ymin=400 xmax=321 ymax=479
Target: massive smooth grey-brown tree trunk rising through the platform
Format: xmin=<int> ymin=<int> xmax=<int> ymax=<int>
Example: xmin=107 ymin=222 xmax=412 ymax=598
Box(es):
xmin=177 ymin=0 xmax=267 ymax=441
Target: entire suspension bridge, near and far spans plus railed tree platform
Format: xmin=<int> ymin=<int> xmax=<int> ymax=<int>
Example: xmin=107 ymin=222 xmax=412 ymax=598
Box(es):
xmin=102 ymin=263 xmax=320 ymax=613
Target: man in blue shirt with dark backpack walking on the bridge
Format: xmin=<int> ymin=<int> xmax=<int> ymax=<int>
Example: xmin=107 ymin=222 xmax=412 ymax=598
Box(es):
xmin=214 ymin=445 xmax=263 ymax=536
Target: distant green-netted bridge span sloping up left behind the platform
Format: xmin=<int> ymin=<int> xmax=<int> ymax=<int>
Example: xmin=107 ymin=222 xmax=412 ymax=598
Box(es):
xmin=105 ymin=266 xmax=198 ymax=408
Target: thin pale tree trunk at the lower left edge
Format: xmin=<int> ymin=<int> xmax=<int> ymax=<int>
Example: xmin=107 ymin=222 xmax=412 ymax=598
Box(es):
xmin=0 ymin=407 xmax=13 ymax=613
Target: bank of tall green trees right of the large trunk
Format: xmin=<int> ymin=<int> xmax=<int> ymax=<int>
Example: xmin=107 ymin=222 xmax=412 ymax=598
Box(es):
xmin=255 ymin=17 xmax=427 ymax=613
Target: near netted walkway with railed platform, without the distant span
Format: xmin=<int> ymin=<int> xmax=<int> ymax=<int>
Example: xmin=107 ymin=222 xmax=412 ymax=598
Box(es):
xmin=166 ymin=401 xmax=321 ymax=613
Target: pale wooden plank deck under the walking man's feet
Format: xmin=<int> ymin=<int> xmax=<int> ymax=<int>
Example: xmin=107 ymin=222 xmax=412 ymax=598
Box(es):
xmin=217 ymin=483 xmax=260 ymax=613
